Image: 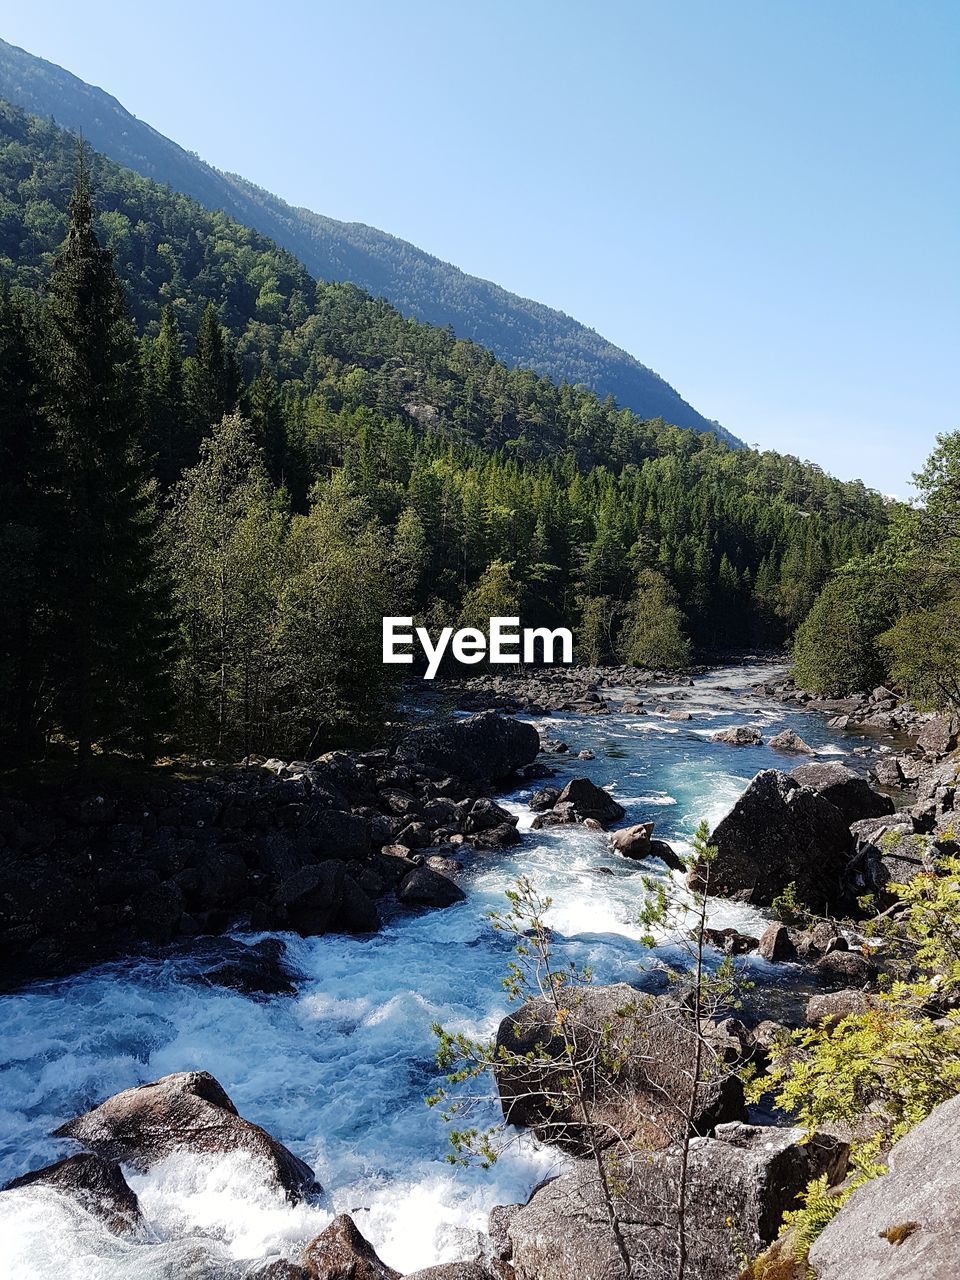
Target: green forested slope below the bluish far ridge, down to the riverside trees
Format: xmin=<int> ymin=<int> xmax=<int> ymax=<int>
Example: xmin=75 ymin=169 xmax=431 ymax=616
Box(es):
xmin=0 ymin=104 xmax=887 ymax=753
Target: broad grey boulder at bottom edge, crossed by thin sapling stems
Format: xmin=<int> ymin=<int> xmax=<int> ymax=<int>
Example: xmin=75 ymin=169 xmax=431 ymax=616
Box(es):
xmin=507 ymin=1124 xmax=844 ymax=1280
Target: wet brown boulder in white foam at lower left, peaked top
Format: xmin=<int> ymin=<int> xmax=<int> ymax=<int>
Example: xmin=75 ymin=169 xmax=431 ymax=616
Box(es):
xmin=54 ymin=1071 xmax=320 ymax=1203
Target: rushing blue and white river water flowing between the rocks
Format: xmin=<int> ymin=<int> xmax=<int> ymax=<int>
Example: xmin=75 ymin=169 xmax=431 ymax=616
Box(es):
xmin=0 ymin=667 xmax=896 ymax=1280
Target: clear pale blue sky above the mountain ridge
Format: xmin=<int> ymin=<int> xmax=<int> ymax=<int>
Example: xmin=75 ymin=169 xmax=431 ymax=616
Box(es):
xmin=0 ymin=0 xmax=960 ymax=494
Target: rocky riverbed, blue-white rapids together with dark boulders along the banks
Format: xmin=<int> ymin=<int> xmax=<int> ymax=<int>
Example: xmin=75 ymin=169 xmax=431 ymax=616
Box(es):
xmin=0 ymin=668 xmax=956 ymax=1280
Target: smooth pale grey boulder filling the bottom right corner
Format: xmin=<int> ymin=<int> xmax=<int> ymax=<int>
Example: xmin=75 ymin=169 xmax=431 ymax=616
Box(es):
xmin=810 ymin=1097 xmax=960 ymax=1280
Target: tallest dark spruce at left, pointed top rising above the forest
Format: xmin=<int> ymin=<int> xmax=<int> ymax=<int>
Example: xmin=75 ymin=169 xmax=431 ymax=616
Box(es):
xmin=45 ymin=152 xmax=166 ymax=760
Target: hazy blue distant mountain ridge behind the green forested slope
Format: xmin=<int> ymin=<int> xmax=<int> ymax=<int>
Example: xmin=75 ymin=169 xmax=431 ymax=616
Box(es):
xmin=0 ymin=40 xmax=742 ymax=448
